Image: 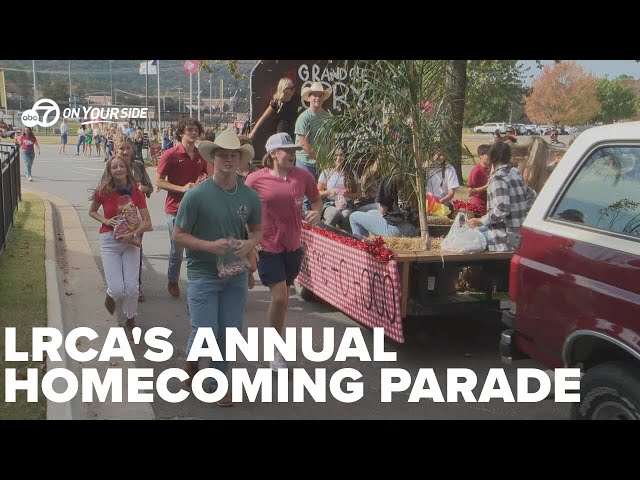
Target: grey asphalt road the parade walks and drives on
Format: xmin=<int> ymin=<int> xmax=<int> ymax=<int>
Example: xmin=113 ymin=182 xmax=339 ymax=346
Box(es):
xmin=18 ymin=145 xmax=569 ymax=419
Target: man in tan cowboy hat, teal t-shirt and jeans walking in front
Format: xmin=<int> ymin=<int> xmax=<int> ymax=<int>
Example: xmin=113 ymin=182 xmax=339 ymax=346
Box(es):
xmin=173 ymin=130 xmax=262 ymax=406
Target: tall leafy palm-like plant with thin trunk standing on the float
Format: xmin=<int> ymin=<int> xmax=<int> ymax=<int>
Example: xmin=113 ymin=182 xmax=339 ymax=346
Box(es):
xmin=315 ymin=60 xmax=451 ymax=249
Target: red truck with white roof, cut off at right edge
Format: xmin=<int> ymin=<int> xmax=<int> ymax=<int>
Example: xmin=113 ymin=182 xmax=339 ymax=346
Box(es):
xmin=500 ymin=122 xmax=640 ymax=420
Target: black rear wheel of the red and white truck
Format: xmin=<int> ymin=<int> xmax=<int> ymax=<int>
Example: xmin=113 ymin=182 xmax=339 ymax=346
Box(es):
xmin=571 ymin=362 xmax=640 ymax=420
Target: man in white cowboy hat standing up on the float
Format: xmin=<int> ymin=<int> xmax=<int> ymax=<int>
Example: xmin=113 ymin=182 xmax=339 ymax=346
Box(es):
xmin=295 ymin=82 xmax=331 ymax=211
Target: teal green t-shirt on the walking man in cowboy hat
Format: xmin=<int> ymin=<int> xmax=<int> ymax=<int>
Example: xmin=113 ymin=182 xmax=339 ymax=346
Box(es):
xmin=176 ymin=178 xmax=262 ymax=278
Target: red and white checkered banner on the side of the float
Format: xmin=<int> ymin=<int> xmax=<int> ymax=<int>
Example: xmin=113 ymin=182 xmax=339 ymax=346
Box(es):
xmin=297 ymin=229 xmax=404 ymax=343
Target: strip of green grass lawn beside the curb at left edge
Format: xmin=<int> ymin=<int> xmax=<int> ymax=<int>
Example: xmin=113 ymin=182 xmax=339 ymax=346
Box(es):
xmin=0 ymin=195 xmax=47 ymax=420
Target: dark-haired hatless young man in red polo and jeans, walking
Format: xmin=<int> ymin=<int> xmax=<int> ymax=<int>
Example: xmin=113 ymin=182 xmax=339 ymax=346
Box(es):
xmin=156 ymin=119 xmax=207 ymax=298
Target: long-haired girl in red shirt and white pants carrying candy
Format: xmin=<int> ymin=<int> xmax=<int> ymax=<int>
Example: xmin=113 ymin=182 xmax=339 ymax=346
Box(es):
xmin=89 ymin=156 xmax=151 ymax=340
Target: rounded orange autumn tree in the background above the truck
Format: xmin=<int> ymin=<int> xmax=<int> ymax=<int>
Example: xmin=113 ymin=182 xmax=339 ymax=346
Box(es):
xmin=525 ymin=61 xmax=600 ymax=125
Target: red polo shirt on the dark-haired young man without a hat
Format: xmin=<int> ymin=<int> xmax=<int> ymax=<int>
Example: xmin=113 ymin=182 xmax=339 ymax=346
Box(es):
xmin=157 ymin=144 xmax=207 ymax=215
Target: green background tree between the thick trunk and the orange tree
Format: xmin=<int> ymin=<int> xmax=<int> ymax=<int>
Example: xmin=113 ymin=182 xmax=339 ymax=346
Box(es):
xmin=464 ymin=60 xmax=528 ymax=127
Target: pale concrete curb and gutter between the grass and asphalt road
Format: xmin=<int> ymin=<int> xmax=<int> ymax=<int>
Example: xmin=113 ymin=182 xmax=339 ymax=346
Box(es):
xmin=23 ymin=188 xmax=155 ymax=420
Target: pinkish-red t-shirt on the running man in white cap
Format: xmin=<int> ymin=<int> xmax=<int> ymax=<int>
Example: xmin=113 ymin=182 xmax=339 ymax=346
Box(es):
xmin=245 ymin=167 xmax=320 ymax=253
